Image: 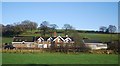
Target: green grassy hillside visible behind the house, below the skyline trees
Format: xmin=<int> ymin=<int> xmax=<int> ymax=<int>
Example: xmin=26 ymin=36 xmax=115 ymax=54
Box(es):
xmin=2 ymin=30 xmax=118 ymax=43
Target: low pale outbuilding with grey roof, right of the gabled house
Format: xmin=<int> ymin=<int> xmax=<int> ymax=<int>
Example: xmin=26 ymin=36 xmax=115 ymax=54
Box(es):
xmin=83 ymin=39 xmax=107 ymax=50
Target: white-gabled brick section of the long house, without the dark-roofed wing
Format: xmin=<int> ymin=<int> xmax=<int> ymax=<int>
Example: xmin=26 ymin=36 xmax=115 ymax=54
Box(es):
xmin=36 ymin=36 xmax=74 ymax=48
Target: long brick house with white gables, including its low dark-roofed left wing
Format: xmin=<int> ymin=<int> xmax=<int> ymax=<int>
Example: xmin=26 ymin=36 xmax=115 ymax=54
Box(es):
xmin=12 ymin=36 xmax=74 ymax=48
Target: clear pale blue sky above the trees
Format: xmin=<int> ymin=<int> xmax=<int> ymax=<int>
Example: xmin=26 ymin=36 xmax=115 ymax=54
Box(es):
xmin=2 ymin=2 xmax=118 ymax=30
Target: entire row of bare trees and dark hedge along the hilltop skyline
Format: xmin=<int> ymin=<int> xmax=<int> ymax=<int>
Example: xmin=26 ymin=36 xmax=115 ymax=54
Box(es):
xmin=0 ymin=20 xmax=117 ymax=36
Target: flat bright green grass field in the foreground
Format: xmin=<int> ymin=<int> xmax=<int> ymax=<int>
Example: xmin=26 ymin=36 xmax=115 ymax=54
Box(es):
xmin=2 ymin=53 xmax=118 ymax=64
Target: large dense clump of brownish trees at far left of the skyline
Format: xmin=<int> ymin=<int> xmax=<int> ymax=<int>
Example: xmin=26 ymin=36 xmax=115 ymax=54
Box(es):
xmin=1 ymin=20 xmax=38 ymax=36
